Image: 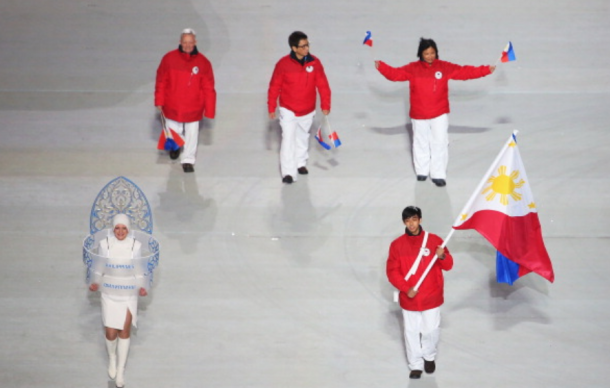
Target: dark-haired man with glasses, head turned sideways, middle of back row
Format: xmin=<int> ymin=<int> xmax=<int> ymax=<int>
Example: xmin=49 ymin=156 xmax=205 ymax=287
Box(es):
xmin=267 ymin=31 xmax=330 ymax=184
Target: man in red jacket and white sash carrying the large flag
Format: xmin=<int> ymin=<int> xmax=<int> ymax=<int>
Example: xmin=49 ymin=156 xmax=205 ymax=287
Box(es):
xmin=386 ymin=206 xmax=453 ymax=379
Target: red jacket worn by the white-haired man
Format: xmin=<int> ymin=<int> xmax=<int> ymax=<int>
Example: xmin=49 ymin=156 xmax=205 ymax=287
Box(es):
xmin=155 ymin=49 xmax=216 ymax=123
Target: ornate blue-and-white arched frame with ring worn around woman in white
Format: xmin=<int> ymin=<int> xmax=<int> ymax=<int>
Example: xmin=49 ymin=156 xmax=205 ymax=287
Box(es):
xmin=83 ymin=176 xmax=159 ymax=295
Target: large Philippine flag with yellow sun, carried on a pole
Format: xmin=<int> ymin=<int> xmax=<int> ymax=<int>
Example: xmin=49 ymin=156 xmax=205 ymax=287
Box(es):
xmin=453 ymin=131 xmax=555 ymax=284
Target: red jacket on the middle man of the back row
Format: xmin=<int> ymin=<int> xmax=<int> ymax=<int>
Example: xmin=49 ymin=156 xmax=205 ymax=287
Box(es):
xmin=267 ymin=55 xmax=330 ymax=116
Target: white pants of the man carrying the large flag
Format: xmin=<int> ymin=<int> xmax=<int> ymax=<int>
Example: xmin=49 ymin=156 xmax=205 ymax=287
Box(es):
xmin=402 ymin=307 xmax=441 ymax=370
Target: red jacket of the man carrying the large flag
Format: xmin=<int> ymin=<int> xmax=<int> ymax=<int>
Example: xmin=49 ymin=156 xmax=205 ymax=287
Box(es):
xmin=386 ymin=231 xmax=453 ymax=311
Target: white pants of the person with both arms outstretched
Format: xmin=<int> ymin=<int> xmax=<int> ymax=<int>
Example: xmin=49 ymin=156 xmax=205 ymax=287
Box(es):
xmin=411 ymin=114 xmax=449 ymax=179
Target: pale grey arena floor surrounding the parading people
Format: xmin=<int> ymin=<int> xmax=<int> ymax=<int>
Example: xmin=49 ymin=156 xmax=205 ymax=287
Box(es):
xmin=0 ymin=0 xmax=610 ymax=388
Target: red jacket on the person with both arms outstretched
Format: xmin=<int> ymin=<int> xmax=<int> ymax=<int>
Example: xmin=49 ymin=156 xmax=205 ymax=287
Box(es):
xmin=378 ymin=59 xmax=491 ymax=120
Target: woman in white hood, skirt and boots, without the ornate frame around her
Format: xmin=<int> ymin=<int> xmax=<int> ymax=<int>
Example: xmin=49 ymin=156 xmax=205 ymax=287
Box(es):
xmin=89 ymin=214 xmax=147 ymax=388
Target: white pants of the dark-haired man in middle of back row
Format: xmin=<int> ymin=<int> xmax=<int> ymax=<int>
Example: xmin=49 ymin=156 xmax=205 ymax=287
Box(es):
xmin=280 ymin=107 xmax=316 ymax=181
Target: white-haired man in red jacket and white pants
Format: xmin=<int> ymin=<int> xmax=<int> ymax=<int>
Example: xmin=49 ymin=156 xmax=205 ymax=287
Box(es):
xmin=155 ymin=28 xmax=216 ymax=172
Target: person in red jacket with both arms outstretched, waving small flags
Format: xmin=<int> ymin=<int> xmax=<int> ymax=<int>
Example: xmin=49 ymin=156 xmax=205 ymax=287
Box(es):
xmin=375 ymin=38 xmax=496 ymax=187
